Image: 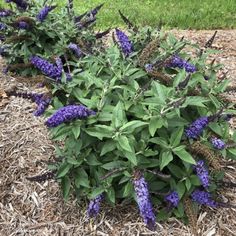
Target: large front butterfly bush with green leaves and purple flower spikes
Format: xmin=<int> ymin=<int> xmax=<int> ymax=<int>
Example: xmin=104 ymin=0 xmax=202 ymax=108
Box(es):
xmin=1 ymin=1 xmax=236 ymax=230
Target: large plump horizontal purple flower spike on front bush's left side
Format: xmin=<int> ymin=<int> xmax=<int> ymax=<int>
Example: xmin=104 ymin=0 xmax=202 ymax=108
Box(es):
xmin=45 ymin=105 xmax=96 ymax=128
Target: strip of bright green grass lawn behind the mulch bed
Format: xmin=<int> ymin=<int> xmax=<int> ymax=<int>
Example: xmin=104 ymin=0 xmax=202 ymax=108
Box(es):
xmin=1 ymin=0 xmax=236 ymax=29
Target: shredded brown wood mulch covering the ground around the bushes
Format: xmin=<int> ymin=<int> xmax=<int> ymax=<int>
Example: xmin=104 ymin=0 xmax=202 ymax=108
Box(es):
xmin=0 ymin=30 xmax=236 ymax=236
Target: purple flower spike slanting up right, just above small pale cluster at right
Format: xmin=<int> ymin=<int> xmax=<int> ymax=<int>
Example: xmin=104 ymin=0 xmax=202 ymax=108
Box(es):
xmin=185 ymin=116 xmax=209 ymax=139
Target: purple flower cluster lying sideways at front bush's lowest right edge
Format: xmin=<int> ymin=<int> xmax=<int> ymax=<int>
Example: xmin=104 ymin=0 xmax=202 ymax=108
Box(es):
xmin=191 ymin=189 xmax=218 ymax=207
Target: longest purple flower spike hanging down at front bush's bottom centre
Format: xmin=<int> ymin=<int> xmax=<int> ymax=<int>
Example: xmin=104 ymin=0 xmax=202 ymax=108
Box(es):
xmin=133 ymin=176 xmax=155 ymax=230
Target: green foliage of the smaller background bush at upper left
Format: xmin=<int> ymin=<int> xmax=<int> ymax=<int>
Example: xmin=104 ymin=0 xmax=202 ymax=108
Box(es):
xmin=1 ymin=0 xmax=95 ymax=76
